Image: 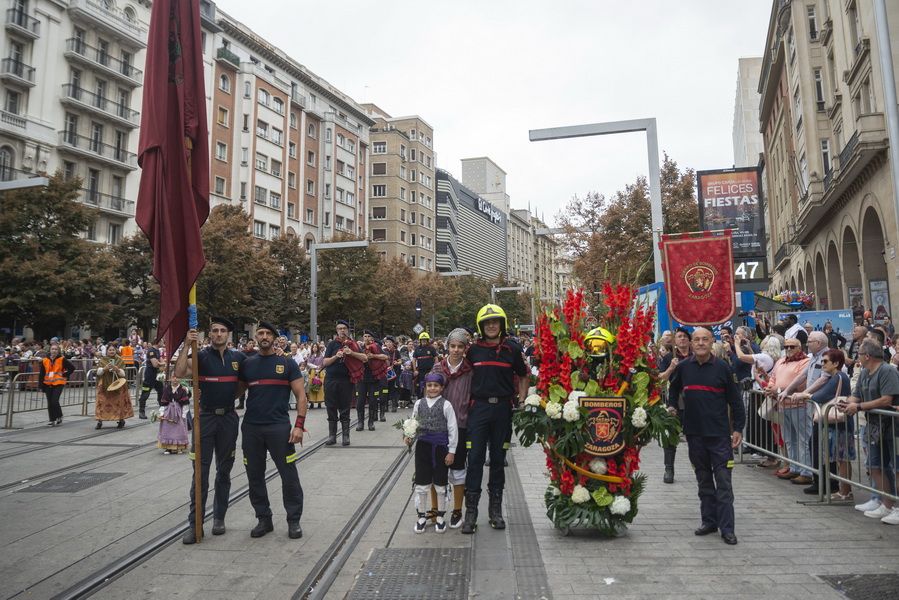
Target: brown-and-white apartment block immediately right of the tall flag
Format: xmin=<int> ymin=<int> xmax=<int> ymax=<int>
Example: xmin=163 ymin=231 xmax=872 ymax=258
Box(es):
xmin=207 ymin=6 xmax=374 ymax=248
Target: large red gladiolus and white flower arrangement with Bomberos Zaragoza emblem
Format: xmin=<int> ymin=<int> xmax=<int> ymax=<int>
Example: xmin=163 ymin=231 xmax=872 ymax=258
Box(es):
xmin=514 ymin=283 xmax=680 ymax=535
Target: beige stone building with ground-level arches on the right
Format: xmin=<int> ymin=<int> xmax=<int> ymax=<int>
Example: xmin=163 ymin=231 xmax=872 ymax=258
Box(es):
xmin=759 ymin=0 xmax=899 ymax=314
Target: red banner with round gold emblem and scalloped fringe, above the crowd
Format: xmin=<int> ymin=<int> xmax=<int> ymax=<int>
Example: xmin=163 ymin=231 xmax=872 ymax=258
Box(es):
xmin=661 ymin=229 xmax=736 ymax=325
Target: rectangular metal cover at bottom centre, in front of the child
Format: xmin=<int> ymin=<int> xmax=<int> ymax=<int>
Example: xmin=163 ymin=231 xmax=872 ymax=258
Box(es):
xmin=348 ymin=548 xmax=471 ymax=600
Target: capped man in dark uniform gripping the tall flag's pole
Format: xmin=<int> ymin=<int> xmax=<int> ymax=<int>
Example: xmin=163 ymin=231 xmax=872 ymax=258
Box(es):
xmin=175 ymin=317 xmax=246 ymax=544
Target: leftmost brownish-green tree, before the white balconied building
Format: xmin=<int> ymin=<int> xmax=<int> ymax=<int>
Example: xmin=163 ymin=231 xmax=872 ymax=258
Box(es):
xmin=0 ymin=173 xmax=122 ymax=337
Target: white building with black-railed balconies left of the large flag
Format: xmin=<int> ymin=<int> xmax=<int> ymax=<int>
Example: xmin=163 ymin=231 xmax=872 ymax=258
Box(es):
xmin=0 ymin=0 xmax=150 ymax=244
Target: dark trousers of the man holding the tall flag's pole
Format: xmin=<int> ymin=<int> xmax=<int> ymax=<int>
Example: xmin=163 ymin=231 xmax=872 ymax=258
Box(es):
xmin=187 ymin=410 xmax=239 ymax=524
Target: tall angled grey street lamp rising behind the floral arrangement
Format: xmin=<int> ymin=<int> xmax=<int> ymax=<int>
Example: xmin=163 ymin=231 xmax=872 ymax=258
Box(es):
xmin=529 ymin=119 xmax=664 ymax=281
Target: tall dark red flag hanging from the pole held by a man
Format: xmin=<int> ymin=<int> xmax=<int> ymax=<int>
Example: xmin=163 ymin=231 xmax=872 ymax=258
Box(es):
xmin=136 ymin=0 xmax=209 ymax=351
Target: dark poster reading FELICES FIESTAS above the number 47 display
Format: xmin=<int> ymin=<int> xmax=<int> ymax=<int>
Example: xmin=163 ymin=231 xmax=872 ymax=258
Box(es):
xmin=696 ymin=167 xmax=767 ymax=258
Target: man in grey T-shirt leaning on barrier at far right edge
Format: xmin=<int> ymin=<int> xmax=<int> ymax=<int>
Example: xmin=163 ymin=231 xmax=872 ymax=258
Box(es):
xmin=843 ymin=340 xmax=899 ymax=525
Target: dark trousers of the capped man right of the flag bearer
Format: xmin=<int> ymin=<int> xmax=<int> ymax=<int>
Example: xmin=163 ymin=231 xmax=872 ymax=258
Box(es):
xmin=241 ymin=421 xmax=303 ymax=522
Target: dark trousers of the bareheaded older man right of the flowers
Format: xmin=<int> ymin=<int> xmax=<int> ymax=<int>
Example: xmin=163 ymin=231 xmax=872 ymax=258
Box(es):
xmin=687 ymin=435 xmax=734 ymax=534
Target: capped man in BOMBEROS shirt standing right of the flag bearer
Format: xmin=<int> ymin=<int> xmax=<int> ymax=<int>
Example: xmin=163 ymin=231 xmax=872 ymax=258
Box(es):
xmin=237 ymin=321 xmax=308 ymax=539
